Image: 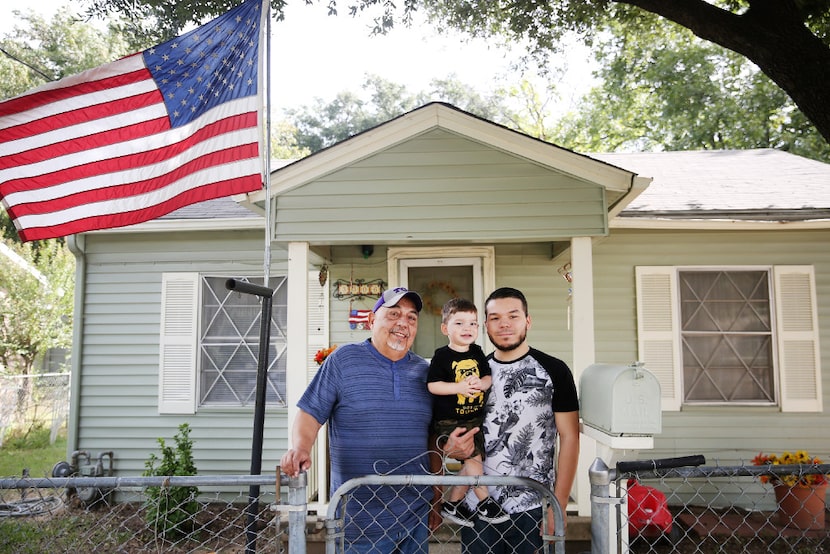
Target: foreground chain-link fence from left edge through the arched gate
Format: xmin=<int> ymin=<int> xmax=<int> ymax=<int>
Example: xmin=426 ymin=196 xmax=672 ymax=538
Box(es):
xmin=0 ymin=474 xmax=565 ymax=554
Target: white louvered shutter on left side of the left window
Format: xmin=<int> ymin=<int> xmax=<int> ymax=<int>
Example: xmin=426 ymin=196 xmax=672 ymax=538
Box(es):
xmin=159 ymin=273 xmax=199 ymax=414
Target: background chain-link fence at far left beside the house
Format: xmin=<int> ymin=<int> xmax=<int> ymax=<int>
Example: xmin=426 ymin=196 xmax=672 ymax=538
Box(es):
xmin=0 ymin=373 xmax=69 ymax=446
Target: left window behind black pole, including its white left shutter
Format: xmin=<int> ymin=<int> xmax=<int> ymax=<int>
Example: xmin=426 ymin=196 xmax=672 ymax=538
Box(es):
xmin=159 ymin=273 xmax=287 ymax=414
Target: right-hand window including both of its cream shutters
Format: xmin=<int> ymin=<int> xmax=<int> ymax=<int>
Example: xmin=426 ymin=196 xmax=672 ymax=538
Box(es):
xmin=636 ymin=266 xmax=821 ymax=411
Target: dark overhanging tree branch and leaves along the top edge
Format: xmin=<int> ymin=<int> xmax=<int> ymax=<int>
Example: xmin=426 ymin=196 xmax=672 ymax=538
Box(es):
xmin=83 ymin=0 xmax=830 ymax=141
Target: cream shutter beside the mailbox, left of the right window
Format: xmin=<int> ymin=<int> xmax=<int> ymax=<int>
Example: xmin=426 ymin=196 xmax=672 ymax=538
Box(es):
xmin=635 ymin=266 xmax=683 ymax=411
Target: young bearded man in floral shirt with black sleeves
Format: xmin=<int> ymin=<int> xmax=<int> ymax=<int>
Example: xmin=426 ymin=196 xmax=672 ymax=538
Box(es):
xmin=452 ymin=287 xmax=579 ymax=554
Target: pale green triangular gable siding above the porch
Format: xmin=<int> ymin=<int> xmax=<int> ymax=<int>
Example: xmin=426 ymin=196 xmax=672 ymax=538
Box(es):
xmin=276 ymin=130 xmax=607 ymax=244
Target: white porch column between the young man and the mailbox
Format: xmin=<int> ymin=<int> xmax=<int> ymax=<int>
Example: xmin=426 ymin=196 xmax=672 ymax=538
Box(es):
xmin=571 ymin=237 xmax=596 ymax=516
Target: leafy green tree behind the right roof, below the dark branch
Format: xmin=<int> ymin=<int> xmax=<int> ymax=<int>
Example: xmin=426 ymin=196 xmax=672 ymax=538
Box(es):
xmin=553 ymin=17 xmax=830 ymax=161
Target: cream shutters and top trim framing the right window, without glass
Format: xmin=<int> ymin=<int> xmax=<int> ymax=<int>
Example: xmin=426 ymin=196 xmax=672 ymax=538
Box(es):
xmin=635 ymin=266 xmax=823 ymax=412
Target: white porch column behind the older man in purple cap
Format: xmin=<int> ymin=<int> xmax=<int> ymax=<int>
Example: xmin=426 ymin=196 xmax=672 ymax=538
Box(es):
xmin=285 ymin=242 xmax=308 ymax=442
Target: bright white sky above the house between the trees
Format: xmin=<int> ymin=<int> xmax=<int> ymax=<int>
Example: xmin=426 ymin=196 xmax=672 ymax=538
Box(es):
xmin=0 ymin=0 xmax=590 ymax=116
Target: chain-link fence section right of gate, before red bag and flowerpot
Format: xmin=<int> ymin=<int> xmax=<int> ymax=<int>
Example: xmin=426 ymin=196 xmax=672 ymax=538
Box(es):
xmin=590 ymin=452 xmax=830 ymax=554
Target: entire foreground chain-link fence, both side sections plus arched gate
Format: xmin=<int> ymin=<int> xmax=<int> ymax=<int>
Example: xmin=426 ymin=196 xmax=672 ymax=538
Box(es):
xmin=0 ymin=459 xmax=830 ymax=554
